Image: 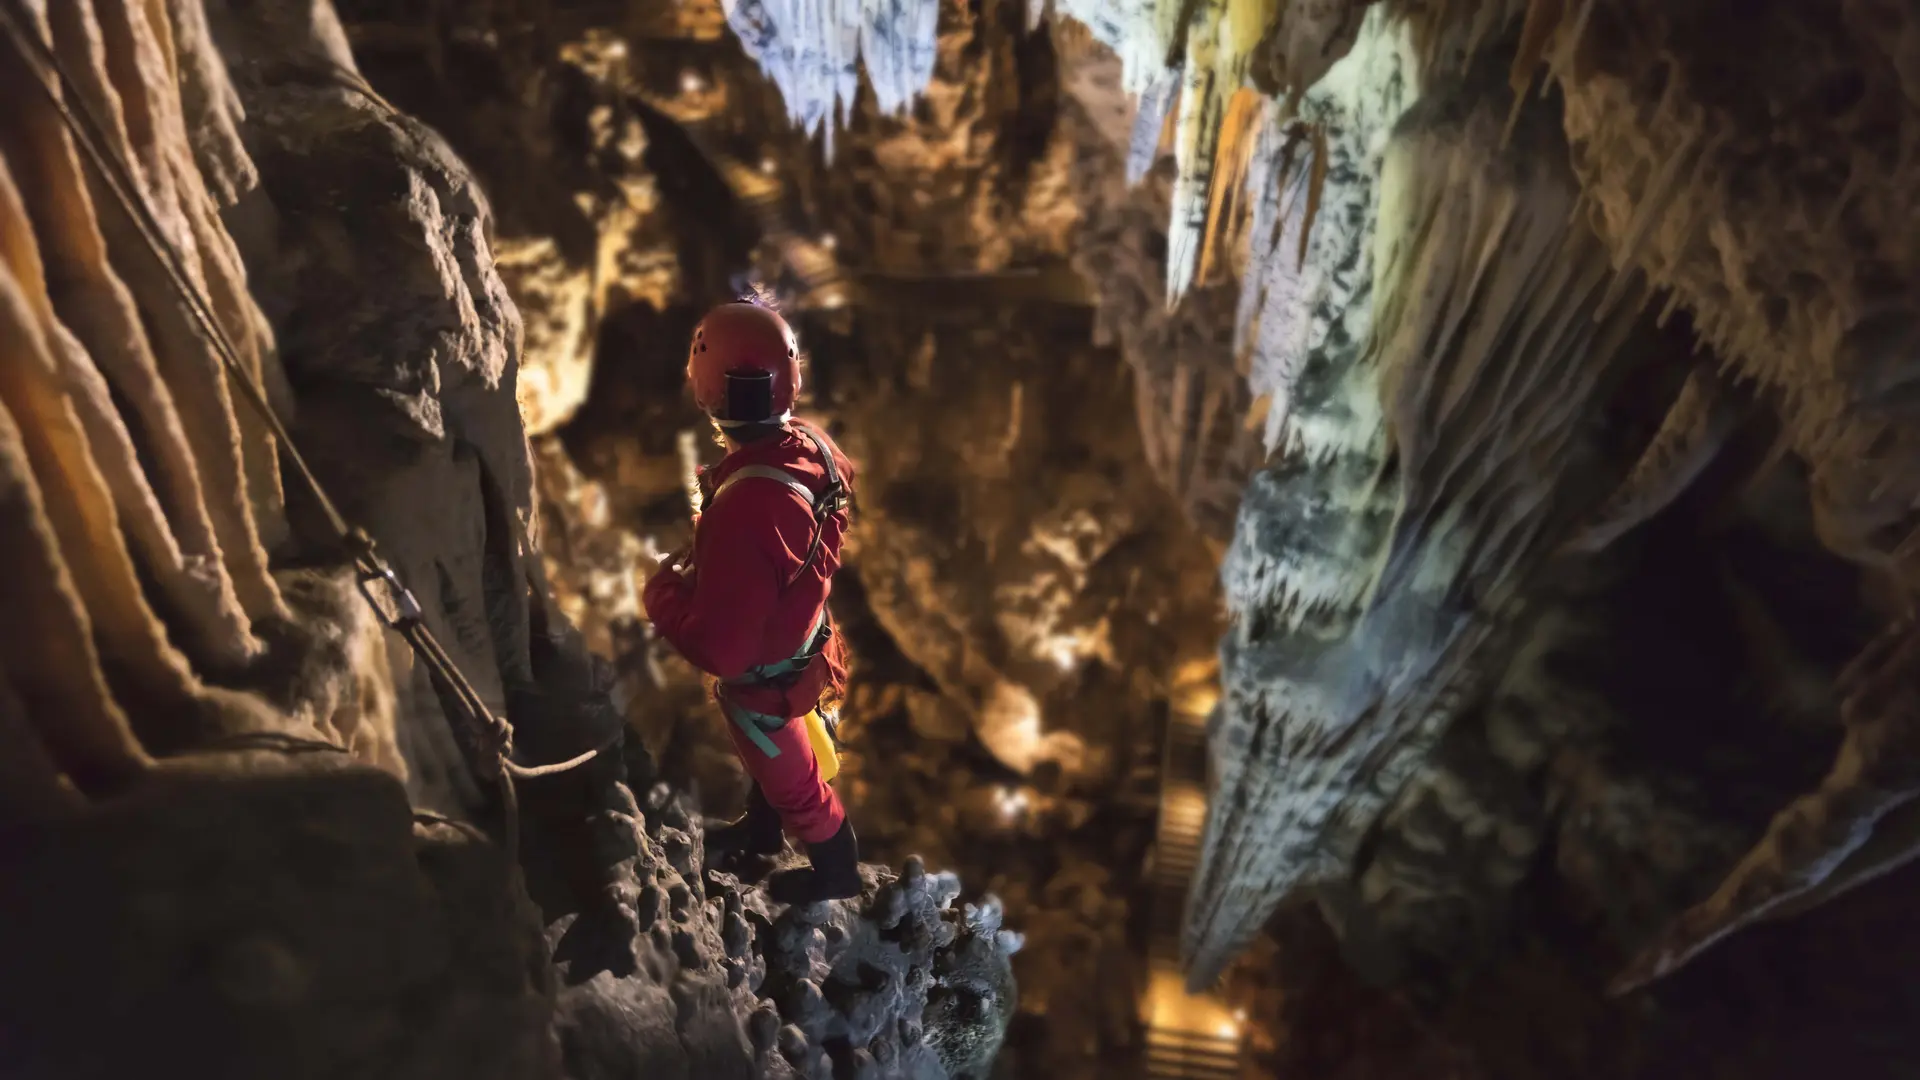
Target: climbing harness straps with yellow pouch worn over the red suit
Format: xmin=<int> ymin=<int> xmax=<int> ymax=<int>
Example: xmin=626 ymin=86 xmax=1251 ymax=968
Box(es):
xmin=701 ymin=421 xmax=849 ymax=768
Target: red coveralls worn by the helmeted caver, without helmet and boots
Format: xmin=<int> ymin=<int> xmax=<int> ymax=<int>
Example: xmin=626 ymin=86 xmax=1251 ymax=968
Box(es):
xmin=641 ymin=429 xmax=852 ymax=844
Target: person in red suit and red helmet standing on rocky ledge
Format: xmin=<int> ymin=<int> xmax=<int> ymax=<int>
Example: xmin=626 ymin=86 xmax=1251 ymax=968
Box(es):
xmin=643 ymin=294 xmax=860 ymax=903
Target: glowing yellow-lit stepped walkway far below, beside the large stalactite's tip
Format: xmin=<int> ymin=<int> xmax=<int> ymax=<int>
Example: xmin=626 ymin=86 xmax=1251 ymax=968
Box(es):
xmin=1140 ymin=711 xmax=1242 ymax=1080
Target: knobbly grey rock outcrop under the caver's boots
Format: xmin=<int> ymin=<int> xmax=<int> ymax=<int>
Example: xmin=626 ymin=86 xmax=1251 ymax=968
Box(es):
xmin=528 ymin=734 xmax=1021 ymax=1080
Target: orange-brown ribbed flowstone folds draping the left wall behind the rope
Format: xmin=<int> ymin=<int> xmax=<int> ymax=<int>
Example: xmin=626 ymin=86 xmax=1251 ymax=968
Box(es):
xmin=0 ymin=0 xmax=426 ymax=794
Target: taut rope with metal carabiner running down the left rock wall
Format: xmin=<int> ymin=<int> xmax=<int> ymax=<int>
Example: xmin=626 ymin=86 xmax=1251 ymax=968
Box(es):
xmin=0 ymin=0 xmax=612 ymax=860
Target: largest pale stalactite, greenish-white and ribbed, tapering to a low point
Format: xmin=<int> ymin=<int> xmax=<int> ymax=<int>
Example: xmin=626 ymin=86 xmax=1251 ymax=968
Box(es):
xmin=1187 ymin=50 xmax=1636 ymax=984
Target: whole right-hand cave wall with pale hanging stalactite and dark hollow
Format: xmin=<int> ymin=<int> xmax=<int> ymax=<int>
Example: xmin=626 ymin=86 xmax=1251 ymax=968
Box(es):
xmin=975 ymin=4 xmax=1912 ymax=1074
